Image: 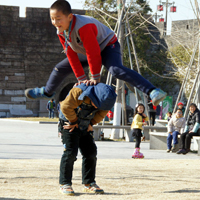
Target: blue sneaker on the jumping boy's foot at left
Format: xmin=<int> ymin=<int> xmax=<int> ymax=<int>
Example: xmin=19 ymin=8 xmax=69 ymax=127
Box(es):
xmin=25 ymin=87 xmax=55 ymax=99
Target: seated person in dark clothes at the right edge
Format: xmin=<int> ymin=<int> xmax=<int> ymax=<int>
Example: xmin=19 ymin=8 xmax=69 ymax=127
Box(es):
xmin=176 ymin=103 xmax=200 ymax=154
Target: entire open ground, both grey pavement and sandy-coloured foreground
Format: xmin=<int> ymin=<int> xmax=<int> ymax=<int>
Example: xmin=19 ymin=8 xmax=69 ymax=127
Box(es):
xmin=0 ymin=119 xmax=200 ymax=200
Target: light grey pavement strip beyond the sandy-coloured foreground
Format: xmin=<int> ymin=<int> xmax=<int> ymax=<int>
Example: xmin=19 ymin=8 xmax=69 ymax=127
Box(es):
xmin=0 ymin=119 xmax=200 ymax=159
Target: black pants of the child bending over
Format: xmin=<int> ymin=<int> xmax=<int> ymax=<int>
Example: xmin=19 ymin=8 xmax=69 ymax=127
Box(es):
xmin=59 ymin=129 xmax=97 ymax=185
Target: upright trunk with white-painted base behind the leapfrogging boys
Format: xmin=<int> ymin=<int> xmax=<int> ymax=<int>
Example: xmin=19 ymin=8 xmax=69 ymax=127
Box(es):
xmin=110 ymin=0 xmax=124 ymax=139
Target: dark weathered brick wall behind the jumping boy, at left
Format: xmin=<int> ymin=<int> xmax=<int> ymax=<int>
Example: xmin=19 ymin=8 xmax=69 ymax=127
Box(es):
xmin=0 ymin=6 xmax=85 ymax=117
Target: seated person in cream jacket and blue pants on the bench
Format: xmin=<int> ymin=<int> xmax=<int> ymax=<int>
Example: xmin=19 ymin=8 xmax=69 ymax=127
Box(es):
xmin=167 ymin=109 xmax=186 ymax=153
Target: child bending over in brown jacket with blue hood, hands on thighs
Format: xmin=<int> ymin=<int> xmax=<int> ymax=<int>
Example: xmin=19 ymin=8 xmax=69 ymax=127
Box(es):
xmin=59 ymin=83 xmax=116 ymax=195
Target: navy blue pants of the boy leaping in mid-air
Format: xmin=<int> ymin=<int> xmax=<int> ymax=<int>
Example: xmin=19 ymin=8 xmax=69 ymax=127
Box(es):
xmin=45 ymin=41 xmax=155 ymax=94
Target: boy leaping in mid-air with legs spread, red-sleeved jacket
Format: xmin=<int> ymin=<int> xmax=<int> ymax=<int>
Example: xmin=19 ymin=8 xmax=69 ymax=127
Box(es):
xmin=25 ymin=0 xmax=167 ymax=105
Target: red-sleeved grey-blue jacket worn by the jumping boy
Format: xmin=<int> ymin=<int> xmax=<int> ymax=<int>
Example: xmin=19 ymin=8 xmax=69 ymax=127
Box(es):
xmin=58 ymin=14 xmax=117 ymax=81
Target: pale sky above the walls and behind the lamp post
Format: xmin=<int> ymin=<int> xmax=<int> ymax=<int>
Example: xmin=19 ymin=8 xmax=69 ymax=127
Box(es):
xmin=0 ymin=0 xmax=200 ymax=34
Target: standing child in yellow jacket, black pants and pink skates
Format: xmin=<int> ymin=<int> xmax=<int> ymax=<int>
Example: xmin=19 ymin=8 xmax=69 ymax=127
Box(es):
xmin=131 ymin=103 xmax=148 ymax=158
